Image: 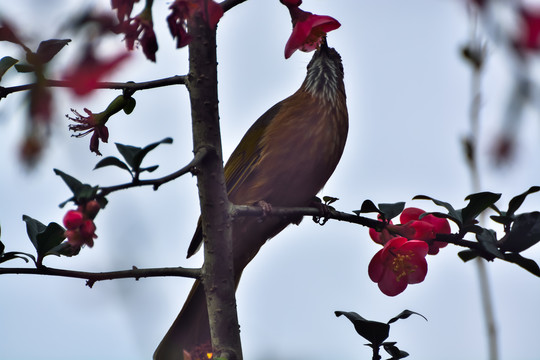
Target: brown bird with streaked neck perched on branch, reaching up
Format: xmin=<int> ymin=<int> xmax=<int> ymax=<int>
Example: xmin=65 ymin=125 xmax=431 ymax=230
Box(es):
xmin=154 ymin=38 xmax=349 ymax=360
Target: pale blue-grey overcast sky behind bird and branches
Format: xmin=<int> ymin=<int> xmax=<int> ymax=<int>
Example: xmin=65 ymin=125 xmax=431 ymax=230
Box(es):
xmin=0 ymin=0 xmax=540 ymax=360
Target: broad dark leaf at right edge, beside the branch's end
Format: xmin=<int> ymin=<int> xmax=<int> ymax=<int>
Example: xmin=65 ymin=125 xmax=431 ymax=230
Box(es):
xmin=501 ymin=211 xmax=540 ymax=252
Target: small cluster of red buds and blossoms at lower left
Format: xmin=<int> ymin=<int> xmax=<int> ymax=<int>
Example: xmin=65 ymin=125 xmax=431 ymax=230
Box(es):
xmin=64 ymin=200 xmax=101 ymax=248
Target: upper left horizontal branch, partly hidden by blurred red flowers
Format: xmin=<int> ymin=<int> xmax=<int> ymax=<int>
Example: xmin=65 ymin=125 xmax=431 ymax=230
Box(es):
xmin=0 ymin=75 xmax=187 ymax=99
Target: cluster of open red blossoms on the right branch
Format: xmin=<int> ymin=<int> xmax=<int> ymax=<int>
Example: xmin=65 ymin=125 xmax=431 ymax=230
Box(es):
xmin=368 ymin=207 xmax=450 ymax=296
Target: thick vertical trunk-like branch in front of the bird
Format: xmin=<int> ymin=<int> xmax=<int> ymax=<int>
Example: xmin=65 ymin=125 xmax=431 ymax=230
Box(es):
xmin=188 ymin=11 xmax=242 ymax=360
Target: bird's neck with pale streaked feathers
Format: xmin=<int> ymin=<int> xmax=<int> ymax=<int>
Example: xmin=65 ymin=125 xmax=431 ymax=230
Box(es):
xmin=302 ymin=56 xmax=345 ymax=103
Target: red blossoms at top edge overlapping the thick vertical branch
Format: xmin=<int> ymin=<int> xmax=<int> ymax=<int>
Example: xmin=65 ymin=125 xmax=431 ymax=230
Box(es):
xmin=167 ymin=0 xmax=223 ymax=48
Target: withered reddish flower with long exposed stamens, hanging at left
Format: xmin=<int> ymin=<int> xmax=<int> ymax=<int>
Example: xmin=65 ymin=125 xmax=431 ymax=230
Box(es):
xmin=66 ymin=108 xmax=109 ymax=155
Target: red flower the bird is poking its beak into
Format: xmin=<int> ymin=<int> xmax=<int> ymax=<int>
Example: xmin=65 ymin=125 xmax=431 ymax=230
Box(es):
xmin=281 ymin=0 xmax=341 ymax=59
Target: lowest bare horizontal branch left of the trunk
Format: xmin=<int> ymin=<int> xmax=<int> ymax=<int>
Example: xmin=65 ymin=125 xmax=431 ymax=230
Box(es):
xmin=0 ymin=266 xmax=201 ymax=287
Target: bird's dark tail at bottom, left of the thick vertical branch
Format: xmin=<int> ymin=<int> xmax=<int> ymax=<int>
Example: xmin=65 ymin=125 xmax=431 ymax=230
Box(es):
xmin=154 ymin=280 xmax=211 ymax=360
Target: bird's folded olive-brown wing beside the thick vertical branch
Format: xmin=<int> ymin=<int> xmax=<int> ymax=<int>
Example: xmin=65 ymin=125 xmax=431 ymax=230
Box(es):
xmin=187 ymin=103 xmax=281 ymax=258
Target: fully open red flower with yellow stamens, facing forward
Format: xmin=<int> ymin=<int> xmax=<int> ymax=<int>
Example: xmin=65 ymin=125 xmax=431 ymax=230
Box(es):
xmin=368 ymin=237 xmax=428 ymax=296
